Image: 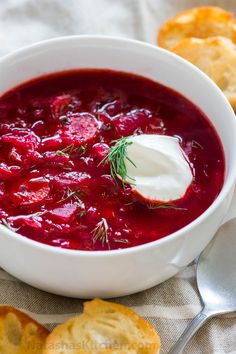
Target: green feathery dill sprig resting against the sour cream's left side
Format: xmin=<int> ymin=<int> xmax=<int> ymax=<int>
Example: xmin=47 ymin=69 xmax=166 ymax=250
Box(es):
xmin=99 ymin=137 xmax=136 ymax=185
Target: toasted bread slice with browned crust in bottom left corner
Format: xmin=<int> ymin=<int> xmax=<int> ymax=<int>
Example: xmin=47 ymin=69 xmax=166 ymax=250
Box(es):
xmin=0 ymin=306 xmax=49 ymax=354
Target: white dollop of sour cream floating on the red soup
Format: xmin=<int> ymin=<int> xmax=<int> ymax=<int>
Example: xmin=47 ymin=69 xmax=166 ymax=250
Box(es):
xmin=124 ymin=134 xmax=193 ymax=202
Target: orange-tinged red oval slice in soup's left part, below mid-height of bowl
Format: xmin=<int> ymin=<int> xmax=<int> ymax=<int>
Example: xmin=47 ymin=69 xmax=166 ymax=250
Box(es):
xmin=9 ymin=177 xmax=50 ymax=206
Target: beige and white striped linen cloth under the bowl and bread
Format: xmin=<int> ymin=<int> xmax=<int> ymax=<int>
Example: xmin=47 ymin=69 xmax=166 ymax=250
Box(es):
xmin=0 ymin=0 xmax=236 ymax=354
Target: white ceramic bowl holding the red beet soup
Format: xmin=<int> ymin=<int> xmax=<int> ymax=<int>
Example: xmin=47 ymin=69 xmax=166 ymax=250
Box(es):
xmin=0 ymin=36 xmax=236 ymax=298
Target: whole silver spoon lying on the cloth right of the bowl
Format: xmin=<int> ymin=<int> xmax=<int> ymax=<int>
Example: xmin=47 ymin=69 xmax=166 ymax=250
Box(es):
xmin=169 ymin=218 xmax=236 ymax=354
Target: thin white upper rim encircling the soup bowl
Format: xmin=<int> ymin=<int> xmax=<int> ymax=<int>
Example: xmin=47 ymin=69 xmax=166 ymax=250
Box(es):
xmin=0 ymin=35 xmax=236 ymax=258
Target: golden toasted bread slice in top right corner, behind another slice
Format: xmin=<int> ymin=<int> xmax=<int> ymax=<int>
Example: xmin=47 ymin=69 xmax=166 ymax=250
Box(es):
xmin=158 ymin=6 xmax=236 ymax=49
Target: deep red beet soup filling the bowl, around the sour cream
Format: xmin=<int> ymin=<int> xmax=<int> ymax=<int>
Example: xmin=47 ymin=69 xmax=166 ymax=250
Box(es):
xmin=0 ymin=69 xmax=225 ymax=250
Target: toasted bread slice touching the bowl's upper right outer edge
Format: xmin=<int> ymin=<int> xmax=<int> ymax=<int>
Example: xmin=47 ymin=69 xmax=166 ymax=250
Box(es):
xmin=172 ymin=37 xmax=236 ymax=110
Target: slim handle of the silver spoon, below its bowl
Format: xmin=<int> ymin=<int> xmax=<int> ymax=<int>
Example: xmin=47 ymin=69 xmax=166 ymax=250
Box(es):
xmin=168 ymin=308 xmax=212 ymax=354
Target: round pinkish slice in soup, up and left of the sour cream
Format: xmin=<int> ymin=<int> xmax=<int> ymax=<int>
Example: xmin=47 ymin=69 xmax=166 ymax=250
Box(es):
xmin=62 ymin=113 xmax=99 ymax=146
